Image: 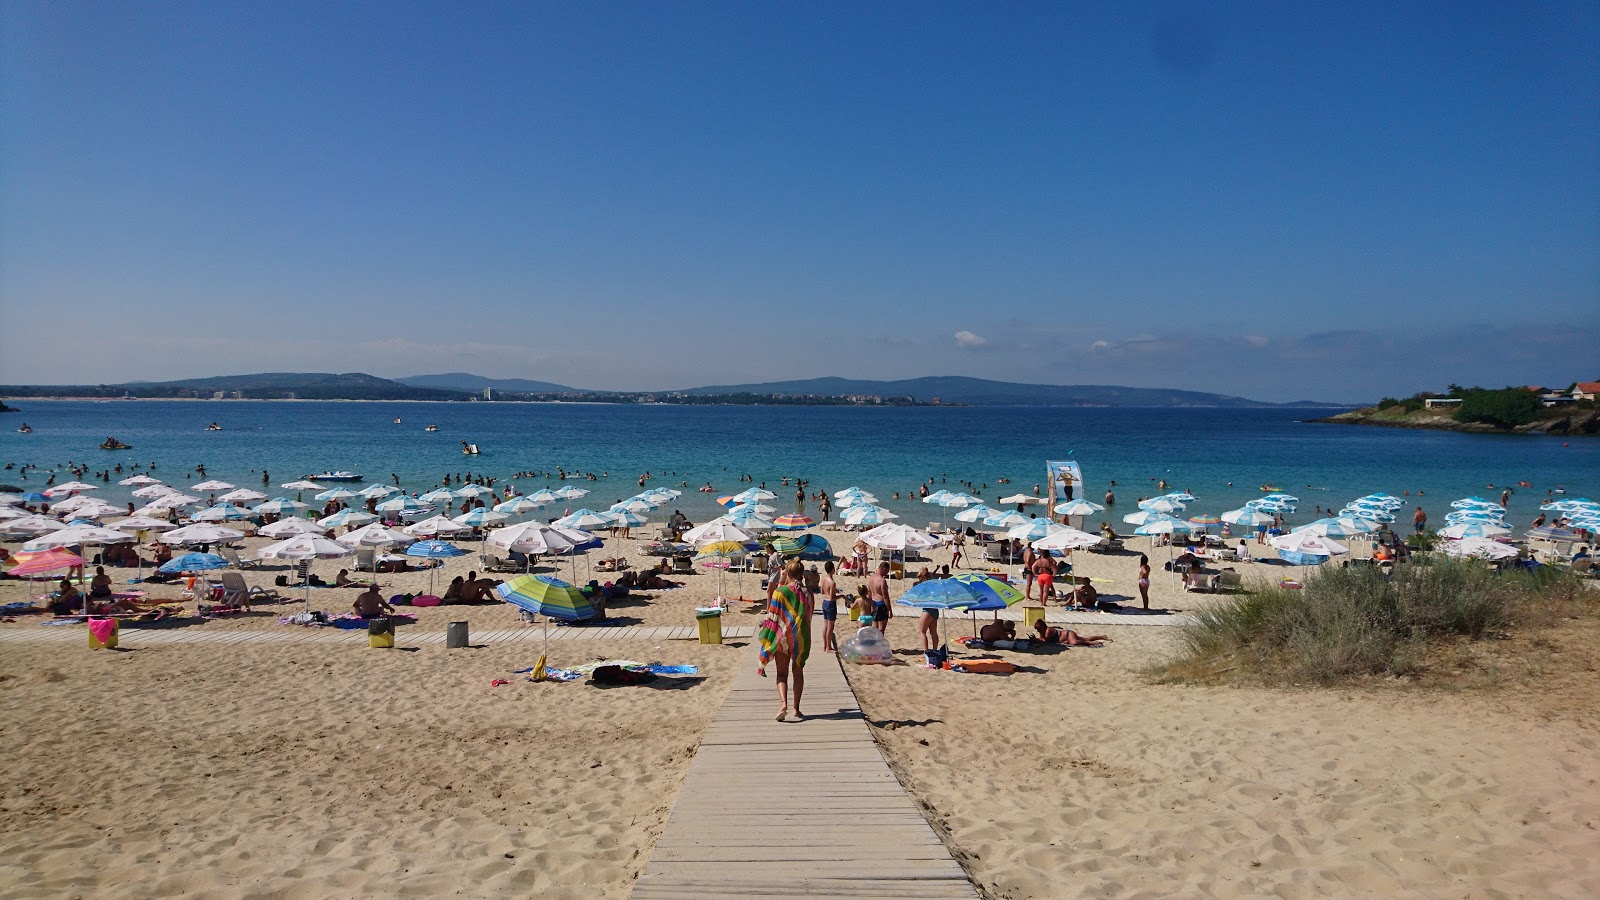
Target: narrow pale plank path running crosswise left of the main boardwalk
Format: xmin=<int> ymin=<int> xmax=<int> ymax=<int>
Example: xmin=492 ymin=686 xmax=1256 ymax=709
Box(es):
xmin=0 ymin=625 xmax=755 ymax=647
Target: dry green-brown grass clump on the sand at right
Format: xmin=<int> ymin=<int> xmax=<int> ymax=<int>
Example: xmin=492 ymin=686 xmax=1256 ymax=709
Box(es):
xmin=1155 ymin=559 xmax=1600 ymax=682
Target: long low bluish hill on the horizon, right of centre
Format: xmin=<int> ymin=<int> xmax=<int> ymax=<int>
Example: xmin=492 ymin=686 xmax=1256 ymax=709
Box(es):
xmin=668 ymin=375 xmax=1339 ymax=407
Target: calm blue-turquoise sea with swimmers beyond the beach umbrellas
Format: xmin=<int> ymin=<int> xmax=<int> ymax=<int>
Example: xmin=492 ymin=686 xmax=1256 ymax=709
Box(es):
xmin=0 ymin=400 xmax=1600 ymax=525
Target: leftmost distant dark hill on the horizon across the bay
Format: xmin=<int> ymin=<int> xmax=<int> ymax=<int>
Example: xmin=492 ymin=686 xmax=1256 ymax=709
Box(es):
xmin=0 ymin=372 xmax=469 ymax=400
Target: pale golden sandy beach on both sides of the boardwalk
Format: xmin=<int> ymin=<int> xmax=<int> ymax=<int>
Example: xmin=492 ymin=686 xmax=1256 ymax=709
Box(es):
xmin=0 ymin=532 xmax=1600 ymax=898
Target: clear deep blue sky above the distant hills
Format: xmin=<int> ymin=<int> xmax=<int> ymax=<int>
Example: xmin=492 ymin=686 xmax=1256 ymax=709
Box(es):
xmin=0 ymin=0 xmax=1600 ymax=400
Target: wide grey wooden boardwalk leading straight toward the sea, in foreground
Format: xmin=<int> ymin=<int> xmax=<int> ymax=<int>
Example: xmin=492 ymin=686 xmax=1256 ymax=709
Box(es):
xmin=634 ymin=652 xmax=978 ymax=900
